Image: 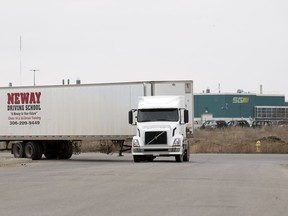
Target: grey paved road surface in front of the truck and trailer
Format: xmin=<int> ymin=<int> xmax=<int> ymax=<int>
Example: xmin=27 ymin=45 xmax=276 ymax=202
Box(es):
xmin=0 ymin=153 xmax=288 ymax=216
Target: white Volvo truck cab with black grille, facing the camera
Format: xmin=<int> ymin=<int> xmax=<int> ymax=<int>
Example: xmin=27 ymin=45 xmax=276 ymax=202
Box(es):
xmin=129 ymin=96 xmax=190 ymax=162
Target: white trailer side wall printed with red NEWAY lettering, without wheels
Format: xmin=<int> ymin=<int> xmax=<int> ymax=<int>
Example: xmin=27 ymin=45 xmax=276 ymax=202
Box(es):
xmin=0 ymin=83 xmax=144 ymax=140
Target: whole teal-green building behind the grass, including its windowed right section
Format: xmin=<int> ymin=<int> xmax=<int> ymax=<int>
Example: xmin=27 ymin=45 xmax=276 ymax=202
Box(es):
xmin=194 ymin=93 xmax=288 ymax=121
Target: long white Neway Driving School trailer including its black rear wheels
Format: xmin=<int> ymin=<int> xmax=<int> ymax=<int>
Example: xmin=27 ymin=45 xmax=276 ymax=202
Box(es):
xmin=0 ymin=80 xmax=193 ymax=161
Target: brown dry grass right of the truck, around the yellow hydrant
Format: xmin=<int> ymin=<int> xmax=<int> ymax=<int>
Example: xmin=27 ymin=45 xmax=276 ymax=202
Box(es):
xmin=190 ymin=127 xmax=288 ymax=153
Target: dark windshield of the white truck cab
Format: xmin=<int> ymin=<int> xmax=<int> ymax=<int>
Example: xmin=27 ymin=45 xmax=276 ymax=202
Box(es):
xmin=137 ymin=109 xmax=179 ymax=122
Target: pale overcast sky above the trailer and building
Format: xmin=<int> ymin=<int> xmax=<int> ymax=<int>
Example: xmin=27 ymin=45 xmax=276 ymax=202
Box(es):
xmin=0 ymin=0 xmax=288 ymax=97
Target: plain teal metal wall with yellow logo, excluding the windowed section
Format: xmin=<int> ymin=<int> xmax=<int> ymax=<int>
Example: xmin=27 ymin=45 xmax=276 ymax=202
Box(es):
xmin=194 ymin=94 xmax=287 ymax=118
